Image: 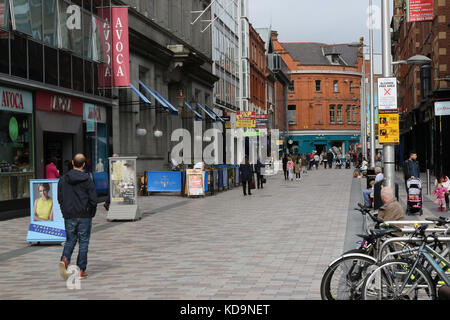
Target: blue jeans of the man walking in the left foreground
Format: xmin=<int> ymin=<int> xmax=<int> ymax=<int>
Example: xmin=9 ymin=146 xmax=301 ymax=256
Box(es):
xmin=62 ymin=218 xmax=92 ymax=271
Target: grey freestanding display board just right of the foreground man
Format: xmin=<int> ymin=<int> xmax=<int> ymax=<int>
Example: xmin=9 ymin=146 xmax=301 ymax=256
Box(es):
xmin=107 ymin=157 xmax=142 ymax=220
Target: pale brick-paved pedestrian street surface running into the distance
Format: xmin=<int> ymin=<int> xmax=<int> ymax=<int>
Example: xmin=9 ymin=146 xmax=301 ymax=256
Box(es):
xmin=0 ymin=169 xmax=359 ymax=300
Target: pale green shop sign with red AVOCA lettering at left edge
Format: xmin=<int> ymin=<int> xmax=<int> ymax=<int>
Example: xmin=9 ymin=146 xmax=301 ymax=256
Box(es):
xmin=0 ymin=87 xmax=33 ymax=113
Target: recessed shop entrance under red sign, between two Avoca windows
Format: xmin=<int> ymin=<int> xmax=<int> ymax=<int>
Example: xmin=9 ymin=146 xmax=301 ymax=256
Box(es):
xmin=35 ymin=91 xmax=83 ymax=179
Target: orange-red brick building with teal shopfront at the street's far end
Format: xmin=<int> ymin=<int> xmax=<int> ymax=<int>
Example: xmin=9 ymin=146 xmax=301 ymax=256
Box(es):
xmin=273 ymin=36 xmax=363 ymax=153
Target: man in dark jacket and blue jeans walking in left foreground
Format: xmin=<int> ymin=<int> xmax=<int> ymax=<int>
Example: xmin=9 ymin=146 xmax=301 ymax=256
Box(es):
xmin=58 ymin=154 xmax=97 ymax=280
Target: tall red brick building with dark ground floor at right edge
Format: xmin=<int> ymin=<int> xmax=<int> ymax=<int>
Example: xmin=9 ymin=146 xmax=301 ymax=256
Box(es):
xmin=392 ymin=0 xmax=450 ymax=175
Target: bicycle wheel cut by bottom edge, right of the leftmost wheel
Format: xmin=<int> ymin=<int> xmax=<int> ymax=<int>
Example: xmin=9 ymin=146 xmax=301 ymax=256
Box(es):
xmin=361 ymin=260 xmax=436 ymax=300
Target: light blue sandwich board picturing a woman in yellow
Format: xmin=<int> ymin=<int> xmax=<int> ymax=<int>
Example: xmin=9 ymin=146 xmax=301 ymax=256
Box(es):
xmin=27 ymin=179 xmax=66 ymax=242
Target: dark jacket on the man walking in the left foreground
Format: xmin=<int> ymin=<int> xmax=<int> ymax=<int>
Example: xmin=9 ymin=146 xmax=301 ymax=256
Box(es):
xmin=58 ymin=170 xmax=97 ymax=219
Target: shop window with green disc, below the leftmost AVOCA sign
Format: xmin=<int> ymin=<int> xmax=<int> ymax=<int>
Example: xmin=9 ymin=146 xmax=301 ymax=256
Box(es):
xmin=0 ymin=111 xmax=34 ymax=201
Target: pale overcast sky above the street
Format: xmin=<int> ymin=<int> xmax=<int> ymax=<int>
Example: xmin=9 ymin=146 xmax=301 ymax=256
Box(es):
xmin=249 ymin=0 xmax=393 ymax=53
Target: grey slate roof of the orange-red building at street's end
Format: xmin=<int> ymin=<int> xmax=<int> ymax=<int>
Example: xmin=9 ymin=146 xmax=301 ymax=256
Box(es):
xmin=281 ymin=42 xmax=359 ymax=66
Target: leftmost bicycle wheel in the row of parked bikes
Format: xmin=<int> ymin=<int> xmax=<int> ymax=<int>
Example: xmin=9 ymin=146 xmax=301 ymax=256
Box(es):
xmin=320 ymin=253 xmax=376 ymax=300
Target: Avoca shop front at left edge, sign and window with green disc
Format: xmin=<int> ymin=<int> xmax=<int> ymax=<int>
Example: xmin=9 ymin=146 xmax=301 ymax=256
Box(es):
xmin=0 ymin=86 xmax=35 ymax=219
